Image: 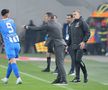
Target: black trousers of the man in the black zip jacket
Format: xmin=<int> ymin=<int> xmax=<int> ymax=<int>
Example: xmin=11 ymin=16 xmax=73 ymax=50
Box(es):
xmin=71 ymin=49 xmax=87 ymax=79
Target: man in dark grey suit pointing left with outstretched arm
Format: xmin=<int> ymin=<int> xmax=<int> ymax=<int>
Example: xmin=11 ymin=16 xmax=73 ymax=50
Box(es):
xmin=25 ymin=12 xmax=67 ymax=85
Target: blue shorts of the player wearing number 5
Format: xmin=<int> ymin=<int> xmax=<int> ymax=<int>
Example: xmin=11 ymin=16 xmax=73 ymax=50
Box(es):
xmin=5 ymin=43 xmax=20 ymax=60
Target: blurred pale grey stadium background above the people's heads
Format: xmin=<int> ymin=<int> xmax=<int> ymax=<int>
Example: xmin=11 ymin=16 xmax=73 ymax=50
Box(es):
xmin=0 ymin=0 xmax=108 ymax=54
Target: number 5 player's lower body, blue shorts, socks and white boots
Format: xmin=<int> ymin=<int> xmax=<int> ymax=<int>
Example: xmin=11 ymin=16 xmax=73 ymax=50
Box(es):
xmin=2 ymin=44 xmax=22 ymax=84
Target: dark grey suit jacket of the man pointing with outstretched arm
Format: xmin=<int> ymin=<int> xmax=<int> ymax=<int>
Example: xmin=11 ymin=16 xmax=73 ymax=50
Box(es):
xmin=28 ymin=20 xmax=66 ymax=46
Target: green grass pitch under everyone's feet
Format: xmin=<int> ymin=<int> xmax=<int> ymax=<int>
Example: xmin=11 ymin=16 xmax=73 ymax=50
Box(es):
xmin=0 ymin=54 xmax=108 ymax=90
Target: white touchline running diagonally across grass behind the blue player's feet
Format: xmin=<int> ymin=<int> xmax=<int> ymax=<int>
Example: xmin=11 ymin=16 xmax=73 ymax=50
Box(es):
xmin=0 ymin=65 xmax=74 ymax=90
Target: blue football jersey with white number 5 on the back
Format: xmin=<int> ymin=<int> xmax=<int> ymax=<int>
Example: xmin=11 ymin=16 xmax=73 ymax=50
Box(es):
xmin=0 ymin=18 xmax=19 ymax=46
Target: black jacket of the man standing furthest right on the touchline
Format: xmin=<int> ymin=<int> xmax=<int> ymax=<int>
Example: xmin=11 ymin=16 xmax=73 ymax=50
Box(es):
xmin=68 ymin=18 xmax=90 ymax=48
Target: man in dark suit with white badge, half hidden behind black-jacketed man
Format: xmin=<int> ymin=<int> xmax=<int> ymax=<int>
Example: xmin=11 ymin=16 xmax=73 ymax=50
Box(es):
xmin=63 ymin=14 xmax=75 ymax=76
